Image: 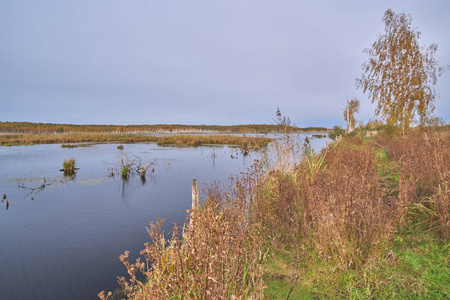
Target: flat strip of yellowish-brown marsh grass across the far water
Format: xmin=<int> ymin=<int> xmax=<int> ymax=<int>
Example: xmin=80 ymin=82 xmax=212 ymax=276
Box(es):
xmin=0 ymin=132 xmax=271 ymax=149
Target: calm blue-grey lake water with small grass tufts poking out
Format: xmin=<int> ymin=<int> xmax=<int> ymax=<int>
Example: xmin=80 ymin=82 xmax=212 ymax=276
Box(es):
xmin=0 ymin=135 xmax=325 ymax=300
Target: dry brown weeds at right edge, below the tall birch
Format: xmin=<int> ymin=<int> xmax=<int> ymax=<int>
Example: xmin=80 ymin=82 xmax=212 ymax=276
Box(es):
xmin=379 ymin=131 xmax=450 ymax=240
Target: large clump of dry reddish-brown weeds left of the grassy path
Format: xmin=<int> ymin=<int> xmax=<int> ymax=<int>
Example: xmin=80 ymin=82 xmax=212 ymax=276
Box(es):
xmin=252 ymin=139 xmax=393 ymax=266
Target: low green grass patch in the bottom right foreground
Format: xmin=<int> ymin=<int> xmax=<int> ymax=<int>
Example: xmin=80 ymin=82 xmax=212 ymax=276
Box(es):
xmin=264 ymin=231 xmax=450 ymax=299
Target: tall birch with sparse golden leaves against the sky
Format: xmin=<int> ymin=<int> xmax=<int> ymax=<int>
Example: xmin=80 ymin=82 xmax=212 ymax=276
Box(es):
xmin=356 ymin=9 xmax=444 ymax=129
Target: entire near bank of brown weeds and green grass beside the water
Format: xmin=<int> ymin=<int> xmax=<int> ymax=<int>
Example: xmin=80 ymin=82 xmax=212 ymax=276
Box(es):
xmin=99 ymin=131 xmax=450 ymax=299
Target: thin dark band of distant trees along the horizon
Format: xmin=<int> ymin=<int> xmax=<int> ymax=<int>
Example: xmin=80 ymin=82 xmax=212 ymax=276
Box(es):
xmin=0 ymin=122 xmax=328 ymax=133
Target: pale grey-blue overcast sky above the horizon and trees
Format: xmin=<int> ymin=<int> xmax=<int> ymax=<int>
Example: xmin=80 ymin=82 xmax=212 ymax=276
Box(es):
xmin=0 ymin=0 xmax=450 ymax=127
